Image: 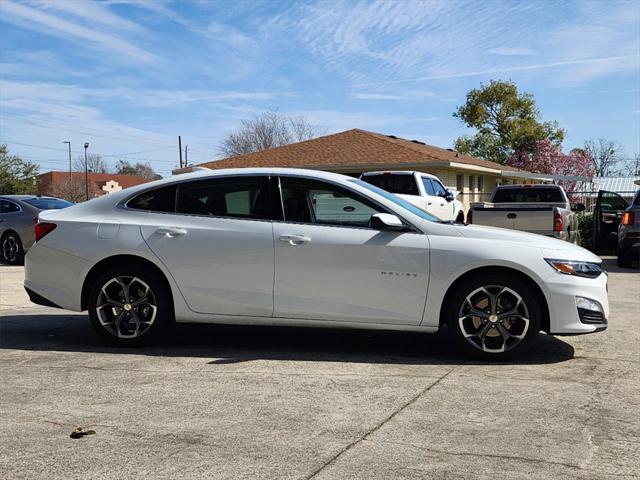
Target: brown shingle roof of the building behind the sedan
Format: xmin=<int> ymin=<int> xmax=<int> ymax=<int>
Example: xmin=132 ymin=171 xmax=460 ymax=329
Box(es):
xmin=202 ymin=128 xmax=517 ymax=171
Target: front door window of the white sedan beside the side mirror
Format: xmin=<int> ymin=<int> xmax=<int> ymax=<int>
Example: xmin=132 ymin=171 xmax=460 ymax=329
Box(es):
xmin=280 ymin=177 xmax=384 ymax=227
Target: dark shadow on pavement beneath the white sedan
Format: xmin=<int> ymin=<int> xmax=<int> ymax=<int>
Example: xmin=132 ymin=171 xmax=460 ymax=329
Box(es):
xmin=0 ymin=314 xmax=574 ymax=365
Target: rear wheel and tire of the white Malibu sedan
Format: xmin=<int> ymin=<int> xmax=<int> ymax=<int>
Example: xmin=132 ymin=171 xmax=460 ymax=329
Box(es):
xmin=87 ymin=265 xmax=174 ymax=347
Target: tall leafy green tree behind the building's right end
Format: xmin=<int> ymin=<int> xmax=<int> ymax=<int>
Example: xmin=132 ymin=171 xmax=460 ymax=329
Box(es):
xmin=453 ymin=80 xmax=565 ymax=164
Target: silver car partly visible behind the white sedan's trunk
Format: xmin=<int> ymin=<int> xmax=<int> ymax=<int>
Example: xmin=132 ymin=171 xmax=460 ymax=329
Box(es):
xmin=0 ymin=195 xmax=73 ymax=265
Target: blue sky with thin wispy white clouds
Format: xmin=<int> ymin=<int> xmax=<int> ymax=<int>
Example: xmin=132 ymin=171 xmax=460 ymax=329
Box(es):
xmin=0 ymin=0 xmax=640 ymax=176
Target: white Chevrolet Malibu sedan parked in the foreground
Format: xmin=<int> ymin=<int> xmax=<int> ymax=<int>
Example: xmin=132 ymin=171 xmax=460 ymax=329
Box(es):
xmin=25 ymin=168 xmax=609 ymax=358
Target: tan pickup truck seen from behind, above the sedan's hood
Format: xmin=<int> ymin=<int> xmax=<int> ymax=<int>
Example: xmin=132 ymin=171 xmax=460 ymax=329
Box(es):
xmin=467 ymin=185 xmax=584 ymax=245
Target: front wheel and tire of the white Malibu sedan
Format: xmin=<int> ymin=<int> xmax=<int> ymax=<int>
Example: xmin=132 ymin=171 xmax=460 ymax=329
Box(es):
xmin=446 ymin=274 xmax=542 ymax=361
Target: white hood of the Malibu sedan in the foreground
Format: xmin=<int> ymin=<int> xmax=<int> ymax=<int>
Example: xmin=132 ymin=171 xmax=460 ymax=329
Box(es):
xmin=456 ymin=225 xmax=602 ymax=263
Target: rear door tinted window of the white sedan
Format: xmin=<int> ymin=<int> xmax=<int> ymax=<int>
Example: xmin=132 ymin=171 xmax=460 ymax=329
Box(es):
xmin=177 ymin=177 xmax=269 ymax=219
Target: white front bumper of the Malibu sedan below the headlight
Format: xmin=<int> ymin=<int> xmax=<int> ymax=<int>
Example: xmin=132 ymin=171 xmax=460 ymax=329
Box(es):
xmin=541 ymin=272 xmax=609 ymax=335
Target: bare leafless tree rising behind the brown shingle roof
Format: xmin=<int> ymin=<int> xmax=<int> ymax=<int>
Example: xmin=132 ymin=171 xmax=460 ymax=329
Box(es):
xmin=219 ymin=110 xmax=325 ymax=157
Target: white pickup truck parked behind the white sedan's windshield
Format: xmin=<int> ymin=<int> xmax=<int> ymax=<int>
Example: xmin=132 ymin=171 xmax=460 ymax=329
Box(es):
xmin=360 ymin=170 xmax=464 ymax=223
